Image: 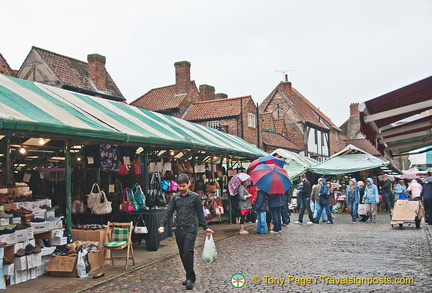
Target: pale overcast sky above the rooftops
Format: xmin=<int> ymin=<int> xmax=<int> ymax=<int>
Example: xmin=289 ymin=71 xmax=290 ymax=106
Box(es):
xmin=0 ymin=0 xmax=432 ymax=126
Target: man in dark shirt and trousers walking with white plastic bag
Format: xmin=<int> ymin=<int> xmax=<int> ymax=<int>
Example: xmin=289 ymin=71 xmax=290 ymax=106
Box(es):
xmin=158 ymin=174 xmax=214 ymax=290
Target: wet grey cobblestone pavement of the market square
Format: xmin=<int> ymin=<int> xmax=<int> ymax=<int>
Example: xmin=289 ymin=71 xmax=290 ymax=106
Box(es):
xmin=82 ymin=213 xmax=432 ymax=292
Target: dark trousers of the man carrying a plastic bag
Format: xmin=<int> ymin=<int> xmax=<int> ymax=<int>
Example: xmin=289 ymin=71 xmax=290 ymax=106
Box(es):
xmin=175 ymin=226 xmax=197 ymax=282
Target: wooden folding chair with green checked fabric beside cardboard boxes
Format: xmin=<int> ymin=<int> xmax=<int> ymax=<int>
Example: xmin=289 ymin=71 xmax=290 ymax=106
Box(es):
xmin=104 ymin=222 xmax=135 ymax=270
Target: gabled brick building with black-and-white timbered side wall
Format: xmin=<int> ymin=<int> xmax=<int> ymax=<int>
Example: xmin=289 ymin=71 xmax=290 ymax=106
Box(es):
xmin=259 ymin=79 xmax=341 ymax=161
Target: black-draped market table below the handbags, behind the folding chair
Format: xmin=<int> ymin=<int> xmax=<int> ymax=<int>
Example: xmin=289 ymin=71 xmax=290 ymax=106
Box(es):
xmin=72 ymin=209 xmax=172 ymax=251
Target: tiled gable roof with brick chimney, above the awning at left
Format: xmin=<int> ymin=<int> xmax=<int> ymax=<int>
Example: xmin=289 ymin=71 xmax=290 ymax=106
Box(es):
xmin=17 ymin=46 xmax=126 ymax=102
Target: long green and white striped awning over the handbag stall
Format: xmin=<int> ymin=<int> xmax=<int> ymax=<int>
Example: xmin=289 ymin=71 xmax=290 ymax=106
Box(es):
xmin=0 ymin=75 xmax=267 ymax=159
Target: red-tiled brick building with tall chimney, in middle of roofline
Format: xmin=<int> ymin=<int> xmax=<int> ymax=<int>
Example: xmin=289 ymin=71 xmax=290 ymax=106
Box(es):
xmin=130 ymin=61 xmax=261 ymax=147
